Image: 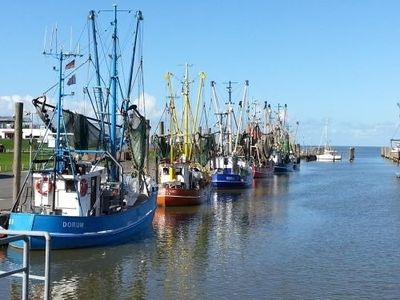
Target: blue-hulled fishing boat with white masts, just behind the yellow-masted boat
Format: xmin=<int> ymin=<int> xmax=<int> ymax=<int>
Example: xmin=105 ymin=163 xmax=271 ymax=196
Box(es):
xmin=211 ymin=81 xmax=253 ymax=189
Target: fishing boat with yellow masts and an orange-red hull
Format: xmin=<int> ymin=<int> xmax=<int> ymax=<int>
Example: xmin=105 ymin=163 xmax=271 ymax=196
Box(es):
xmin=156 ymin=64 xmax=209 ymax=206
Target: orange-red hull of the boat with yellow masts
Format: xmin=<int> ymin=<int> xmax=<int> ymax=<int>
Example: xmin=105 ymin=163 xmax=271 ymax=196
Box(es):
xmin=157 ymin=185 xmax=210 ymax=206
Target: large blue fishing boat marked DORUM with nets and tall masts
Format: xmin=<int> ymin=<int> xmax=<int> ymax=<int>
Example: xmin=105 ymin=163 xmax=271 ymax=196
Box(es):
xmin=8 ymin=6 xmax=156 ymax=249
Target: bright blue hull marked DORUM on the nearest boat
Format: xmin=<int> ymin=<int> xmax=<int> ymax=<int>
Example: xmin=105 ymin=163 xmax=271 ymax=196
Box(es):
xmin=8 ymin=195 xmax=156 ymax=249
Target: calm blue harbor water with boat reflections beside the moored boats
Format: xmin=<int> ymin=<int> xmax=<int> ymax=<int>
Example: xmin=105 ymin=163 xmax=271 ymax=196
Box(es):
xmin=0 ymin=147 xmax=400 ymax=299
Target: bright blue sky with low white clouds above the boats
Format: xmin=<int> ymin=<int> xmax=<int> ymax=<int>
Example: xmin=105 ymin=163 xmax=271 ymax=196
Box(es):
xmin=0 ymin=0 xmax=400 ymax=146
